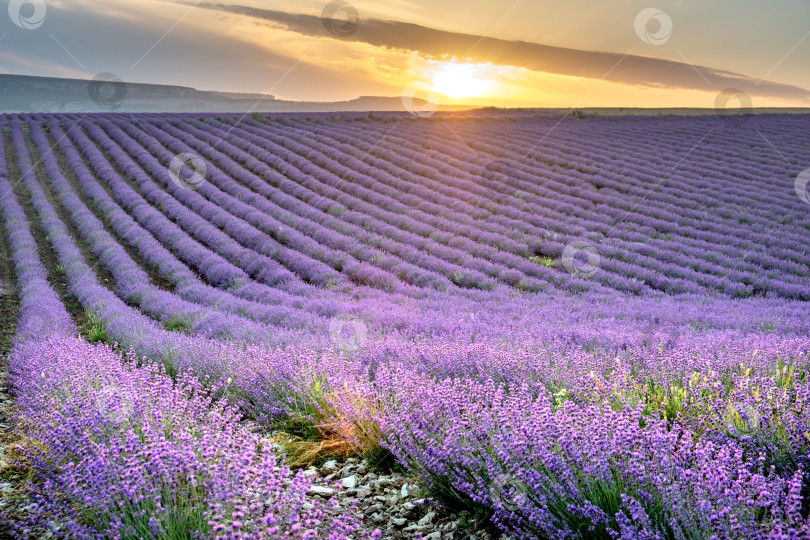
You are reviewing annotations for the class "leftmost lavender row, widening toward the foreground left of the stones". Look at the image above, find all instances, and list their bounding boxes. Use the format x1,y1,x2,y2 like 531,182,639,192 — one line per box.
0,136,366,539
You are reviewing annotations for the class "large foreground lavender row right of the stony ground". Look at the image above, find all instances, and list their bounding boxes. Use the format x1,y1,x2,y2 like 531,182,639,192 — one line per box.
383,360,808,538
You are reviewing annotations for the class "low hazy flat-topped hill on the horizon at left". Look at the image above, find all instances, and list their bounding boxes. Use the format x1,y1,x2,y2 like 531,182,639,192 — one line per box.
0,74,474,113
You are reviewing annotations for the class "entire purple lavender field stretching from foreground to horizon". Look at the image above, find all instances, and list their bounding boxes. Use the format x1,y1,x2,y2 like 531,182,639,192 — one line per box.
0,110,810,540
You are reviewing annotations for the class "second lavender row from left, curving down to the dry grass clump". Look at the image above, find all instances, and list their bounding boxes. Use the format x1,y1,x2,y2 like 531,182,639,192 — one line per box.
11,118,408,422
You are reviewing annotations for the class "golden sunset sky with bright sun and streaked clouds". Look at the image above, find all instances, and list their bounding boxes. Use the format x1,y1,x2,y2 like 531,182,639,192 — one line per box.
0,0,810,107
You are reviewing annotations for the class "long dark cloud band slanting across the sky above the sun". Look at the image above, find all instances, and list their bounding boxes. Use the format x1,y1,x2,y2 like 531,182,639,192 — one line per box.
193,3,810,101
